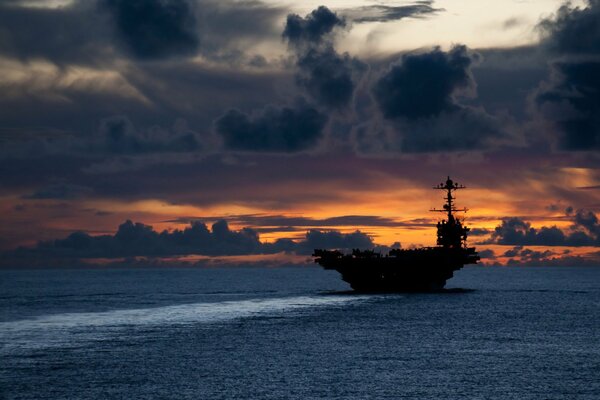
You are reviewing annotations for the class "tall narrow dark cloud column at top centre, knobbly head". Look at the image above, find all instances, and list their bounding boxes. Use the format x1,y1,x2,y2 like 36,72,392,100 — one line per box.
283,6,366,109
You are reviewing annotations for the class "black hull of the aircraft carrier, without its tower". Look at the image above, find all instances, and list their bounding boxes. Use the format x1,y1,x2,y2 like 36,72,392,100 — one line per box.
315,247,479,292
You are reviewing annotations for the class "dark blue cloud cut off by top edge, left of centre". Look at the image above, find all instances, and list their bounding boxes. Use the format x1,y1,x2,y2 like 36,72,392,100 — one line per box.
99,0,199,59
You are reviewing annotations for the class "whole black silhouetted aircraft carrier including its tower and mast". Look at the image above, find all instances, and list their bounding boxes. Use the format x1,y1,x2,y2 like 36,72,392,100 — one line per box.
313,177,479,292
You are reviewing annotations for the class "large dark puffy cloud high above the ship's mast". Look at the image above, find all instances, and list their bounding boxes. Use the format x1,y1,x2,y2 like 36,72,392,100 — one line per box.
370,45,505,153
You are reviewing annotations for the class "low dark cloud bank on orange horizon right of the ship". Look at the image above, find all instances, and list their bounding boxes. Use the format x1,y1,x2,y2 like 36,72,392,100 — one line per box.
485,210,600,246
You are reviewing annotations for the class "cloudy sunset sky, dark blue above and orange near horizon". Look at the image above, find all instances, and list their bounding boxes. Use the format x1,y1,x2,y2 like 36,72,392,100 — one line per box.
0,0,600,266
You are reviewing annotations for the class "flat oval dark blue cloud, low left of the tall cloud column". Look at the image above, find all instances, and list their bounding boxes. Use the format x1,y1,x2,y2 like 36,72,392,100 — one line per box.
215,104,327,153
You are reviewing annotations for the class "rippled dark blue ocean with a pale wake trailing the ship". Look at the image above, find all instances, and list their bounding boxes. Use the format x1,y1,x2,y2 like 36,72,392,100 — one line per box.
0,267,600,399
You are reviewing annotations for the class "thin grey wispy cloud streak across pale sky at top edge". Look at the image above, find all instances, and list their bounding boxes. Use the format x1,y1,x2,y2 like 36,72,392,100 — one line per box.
340,0,444,23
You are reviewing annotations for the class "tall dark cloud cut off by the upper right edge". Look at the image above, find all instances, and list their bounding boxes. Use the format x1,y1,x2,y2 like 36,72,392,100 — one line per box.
533,0,600,151
